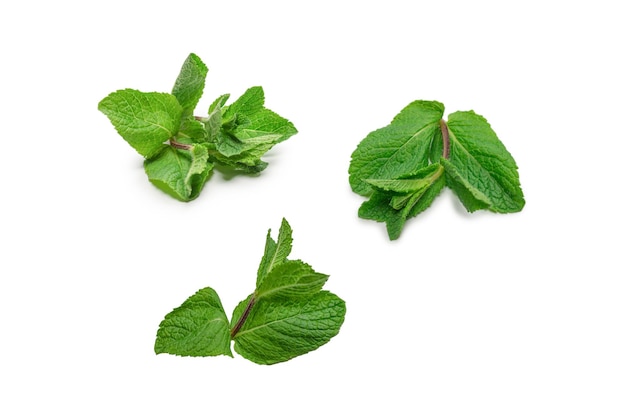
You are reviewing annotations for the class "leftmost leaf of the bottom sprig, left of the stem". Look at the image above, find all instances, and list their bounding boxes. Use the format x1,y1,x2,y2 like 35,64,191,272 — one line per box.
154,287,232,357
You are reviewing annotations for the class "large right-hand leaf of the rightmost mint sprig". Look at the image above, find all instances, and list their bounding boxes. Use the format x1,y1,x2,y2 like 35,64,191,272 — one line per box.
447,111,525,213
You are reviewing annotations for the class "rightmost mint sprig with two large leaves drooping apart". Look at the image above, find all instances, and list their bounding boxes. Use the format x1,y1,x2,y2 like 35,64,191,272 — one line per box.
348,100,525,240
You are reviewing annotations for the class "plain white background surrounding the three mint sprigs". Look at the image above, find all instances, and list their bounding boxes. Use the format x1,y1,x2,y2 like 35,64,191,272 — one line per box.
0,0,626,418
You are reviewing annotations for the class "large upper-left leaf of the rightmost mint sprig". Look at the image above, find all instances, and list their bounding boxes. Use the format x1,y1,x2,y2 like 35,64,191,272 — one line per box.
348,100,444,196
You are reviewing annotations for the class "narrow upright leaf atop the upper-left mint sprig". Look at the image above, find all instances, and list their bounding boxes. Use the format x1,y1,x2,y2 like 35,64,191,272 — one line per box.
172,54,209,114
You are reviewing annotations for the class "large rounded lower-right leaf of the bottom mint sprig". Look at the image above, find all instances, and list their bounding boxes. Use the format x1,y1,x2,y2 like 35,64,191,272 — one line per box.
232,291,346,364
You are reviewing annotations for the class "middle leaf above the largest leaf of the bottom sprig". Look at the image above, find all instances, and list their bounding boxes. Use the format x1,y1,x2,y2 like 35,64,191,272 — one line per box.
255,260,328,300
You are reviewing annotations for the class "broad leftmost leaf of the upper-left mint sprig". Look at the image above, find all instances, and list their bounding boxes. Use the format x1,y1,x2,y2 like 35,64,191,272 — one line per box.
98,89,183,158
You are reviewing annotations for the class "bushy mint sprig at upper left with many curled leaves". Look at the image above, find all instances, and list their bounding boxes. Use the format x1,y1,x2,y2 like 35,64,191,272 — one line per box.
98,54,297,202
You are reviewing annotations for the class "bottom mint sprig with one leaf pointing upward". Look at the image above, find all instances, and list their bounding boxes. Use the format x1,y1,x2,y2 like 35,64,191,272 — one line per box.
154,219,346,364
